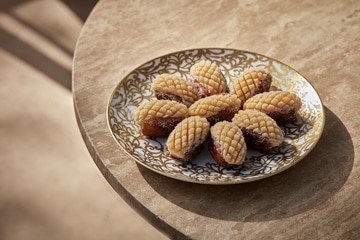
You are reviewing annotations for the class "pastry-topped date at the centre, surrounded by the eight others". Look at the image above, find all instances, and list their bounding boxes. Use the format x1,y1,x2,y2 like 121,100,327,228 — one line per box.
189,93,241,125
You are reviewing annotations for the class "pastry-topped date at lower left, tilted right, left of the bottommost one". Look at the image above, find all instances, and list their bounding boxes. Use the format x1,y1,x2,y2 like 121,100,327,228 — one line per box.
165,116,210,162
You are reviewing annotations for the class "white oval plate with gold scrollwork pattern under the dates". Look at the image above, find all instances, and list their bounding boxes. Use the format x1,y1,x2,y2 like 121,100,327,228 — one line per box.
107,48,325,184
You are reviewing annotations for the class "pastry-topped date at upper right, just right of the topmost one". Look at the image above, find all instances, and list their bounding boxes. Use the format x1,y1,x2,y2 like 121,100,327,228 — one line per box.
230,68,272,103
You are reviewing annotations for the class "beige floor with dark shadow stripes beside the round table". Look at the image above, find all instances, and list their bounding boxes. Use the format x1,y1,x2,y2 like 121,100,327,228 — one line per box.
0,0,166,240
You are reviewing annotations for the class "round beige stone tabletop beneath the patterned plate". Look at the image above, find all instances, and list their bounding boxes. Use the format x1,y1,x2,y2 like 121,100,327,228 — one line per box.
73,0,360,239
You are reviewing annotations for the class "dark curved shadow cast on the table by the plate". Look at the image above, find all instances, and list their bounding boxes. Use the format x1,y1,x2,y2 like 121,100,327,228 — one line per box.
138,108,354,222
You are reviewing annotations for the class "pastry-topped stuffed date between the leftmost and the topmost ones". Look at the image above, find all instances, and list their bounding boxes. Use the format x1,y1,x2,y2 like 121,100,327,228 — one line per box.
151,73,199,107
